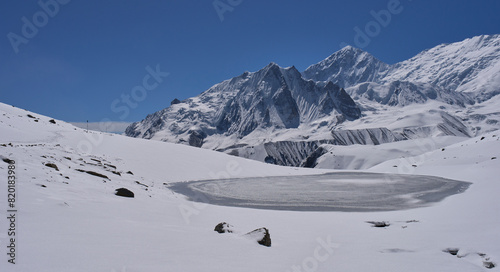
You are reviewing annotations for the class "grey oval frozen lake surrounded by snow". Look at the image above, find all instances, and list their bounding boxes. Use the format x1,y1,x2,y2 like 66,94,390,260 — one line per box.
169,172,470,212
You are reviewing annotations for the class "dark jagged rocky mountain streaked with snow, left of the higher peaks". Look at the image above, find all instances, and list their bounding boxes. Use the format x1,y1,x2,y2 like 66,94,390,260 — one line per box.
126,63,361,148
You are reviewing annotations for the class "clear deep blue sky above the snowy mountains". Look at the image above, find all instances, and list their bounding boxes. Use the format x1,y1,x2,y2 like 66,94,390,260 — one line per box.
0,0,500,122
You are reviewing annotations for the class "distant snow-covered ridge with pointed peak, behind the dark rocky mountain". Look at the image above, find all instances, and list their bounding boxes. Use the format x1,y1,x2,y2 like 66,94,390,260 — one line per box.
303,35,500,102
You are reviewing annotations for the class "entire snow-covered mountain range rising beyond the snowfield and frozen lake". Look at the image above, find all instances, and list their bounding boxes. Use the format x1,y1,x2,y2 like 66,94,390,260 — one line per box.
126,35,500,166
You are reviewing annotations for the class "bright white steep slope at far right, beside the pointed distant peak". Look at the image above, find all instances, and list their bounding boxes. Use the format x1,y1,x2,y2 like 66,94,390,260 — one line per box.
380,35,500,101
